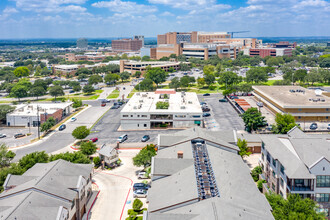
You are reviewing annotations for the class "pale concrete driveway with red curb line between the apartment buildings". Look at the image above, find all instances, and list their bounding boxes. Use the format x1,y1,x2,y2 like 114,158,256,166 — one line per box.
90,150,146,220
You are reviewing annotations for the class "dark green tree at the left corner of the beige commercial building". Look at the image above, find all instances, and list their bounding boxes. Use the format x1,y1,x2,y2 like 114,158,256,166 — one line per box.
242,108,265,132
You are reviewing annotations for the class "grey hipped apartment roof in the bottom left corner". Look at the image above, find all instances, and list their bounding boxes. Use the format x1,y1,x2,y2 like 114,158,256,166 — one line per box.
0,160,93,219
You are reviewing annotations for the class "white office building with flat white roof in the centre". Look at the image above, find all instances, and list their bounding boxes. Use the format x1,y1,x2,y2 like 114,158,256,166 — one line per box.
120,89,203,130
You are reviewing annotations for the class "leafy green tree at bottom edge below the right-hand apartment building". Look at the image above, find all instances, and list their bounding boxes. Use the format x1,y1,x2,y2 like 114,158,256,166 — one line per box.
266,193,325,220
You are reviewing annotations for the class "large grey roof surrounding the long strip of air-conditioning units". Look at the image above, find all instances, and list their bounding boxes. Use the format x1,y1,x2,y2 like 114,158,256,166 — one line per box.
147,128,274,220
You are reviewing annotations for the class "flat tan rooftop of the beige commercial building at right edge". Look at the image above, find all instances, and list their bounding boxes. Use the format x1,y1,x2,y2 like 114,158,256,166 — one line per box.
253,86,330,108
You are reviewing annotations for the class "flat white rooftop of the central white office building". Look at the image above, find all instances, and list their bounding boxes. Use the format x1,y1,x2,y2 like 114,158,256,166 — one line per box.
121,90,203,114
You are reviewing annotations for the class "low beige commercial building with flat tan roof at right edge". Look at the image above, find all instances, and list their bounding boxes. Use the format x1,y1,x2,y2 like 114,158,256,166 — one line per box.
253,86,330,122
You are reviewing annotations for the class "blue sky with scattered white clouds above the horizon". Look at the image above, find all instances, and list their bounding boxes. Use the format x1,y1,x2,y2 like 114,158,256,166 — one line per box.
0,0,330,39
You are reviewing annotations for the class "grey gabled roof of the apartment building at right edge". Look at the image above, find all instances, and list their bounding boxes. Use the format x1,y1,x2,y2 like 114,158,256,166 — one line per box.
259,127,330,179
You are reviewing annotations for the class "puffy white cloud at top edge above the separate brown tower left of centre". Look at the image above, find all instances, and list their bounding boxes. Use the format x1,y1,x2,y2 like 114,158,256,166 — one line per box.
92,0,157,15
